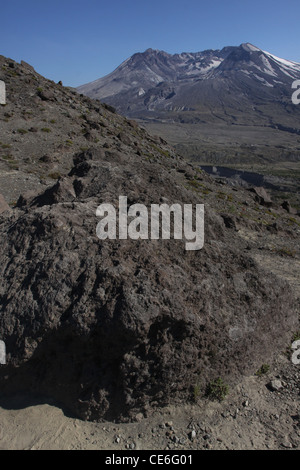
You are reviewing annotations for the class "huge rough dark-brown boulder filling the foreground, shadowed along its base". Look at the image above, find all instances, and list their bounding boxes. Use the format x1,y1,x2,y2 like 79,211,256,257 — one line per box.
0,151,296,420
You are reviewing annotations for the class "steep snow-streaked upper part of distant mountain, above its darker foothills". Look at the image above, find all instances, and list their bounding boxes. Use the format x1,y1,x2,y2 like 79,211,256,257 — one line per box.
78,43,300,109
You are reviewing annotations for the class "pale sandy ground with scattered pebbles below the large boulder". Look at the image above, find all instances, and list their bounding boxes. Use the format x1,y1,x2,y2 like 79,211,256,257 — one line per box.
0,355,300,450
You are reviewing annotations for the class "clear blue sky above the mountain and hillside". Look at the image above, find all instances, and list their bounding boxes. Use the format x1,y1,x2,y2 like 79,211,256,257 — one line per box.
0,0,300,86
